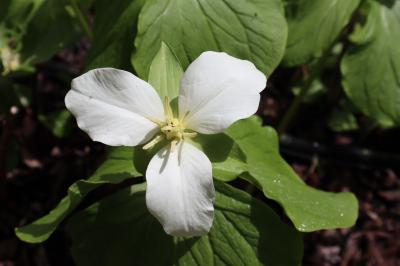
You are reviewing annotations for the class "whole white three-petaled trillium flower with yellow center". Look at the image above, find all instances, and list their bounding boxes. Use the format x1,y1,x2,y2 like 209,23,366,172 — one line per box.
65,52,266,236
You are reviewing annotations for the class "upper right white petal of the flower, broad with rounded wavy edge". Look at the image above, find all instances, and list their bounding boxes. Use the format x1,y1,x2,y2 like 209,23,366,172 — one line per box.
179,52,267,134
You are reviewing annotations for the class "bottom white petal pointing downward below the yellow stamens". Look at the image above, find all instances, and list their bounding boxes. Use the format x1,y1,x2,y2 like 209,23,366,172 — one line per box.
146,141,215,236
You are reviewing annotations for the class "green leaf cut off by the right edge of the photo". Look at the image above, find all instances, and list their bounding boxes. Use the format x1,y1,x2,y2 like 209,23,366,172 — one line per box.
341,0,400,126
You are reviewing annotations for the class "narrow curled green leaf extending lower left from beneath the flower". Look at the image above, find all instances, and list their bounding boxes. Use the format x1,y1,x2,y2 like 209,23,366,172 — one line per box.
15,148,141,243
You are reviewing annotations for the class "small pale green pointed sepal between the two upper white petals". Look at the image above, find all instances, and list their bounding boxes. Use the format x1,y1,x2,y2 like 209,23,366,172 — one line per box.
148,42,183,101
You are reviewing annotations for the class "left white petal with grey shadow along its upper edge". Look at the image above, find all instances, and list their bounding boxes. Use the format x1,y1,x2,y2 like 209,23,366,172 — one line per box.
65,68,164,146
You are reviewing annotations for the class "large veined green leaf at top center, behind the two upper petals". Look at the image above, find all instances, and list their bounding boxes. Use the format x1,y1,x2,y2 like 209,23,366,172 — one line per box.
132,0,287,78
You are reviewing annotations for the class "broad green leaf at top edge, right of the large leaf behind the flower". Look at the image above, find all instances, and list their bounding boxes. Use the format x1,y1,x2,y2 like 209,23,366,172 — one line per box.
283,0,360,66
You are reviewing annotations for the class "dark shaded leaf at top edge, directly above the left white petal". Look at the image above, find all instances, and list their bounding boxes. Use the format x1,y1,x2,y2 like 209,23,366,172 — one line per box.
86,0,145,70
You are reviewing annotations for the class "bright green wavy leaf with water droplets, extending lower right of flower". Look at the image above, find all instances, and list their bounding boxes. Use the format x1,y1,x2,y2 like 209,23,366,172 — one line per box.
226,118,358,232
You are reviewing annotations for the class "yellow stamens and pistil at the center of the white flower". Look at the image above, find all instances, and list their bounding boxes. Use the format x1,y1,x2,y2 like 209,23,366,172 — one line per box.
143,97,197,150
